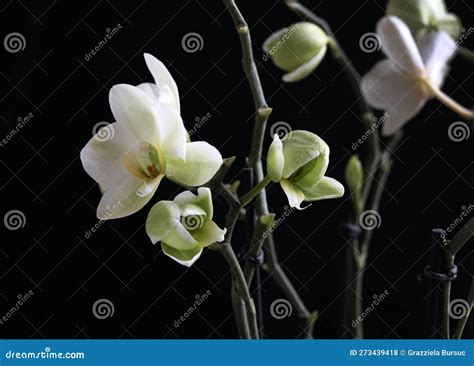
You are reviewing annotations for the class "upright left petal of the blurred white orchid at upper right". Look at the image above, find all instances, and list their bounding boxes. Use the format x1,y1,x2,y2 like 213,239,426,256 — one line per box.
377,16,425,76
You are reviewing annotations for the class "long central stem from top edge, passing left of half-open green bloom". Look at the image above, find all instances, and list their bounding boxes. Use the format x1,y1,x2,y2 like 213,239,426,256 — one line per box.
224,0,314,338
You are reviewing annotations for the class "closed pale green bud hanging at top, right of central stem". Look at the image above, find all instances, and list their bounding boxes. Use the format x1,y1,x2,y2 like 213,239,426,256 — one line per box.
263,22,329,82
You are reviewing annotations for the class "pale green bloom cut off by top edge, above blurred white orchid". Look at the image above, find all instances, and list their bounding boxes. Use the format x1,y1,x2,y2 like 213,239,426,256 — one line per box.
387,0,462,39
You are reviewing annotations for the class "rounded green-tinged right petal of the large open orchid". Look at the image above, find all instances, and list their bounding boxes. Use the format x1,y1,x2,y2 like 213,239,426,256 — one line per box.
166,141,223,187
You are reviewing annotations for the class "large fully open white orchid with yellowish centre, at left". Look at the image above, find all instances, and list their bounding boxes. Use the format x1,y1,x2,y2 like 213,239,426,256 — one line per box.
81,55,223,220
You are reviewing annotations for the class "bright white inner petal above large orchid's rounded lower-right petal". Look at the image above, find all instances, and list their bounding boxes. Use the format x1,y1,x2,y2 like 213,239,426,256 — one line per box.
155,102,187,159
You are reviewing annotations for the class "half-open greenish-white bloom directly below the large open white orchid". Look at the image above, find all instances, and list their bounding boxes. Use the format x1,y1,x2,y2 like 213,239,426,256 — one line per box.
146,187,226,267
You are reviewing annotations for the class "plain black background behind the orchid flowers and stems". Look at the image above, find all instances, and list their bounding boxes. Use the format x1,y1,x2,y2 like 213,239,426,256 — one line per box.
0,0,474,338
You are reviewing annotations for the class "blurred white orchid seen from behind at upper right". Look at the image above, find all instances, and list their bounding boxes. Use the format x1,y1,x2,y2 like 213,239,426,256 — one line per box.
361,16,458,135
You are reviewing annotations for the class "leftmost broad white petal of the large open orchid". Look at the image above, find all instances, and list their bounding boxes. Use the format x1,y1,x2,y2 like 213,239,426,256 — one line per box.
81,122,139,189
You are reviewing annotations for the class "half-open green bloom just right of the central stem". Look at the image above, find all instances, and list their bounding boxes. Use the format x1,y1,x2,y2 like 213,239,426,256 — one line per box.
267,130,344,209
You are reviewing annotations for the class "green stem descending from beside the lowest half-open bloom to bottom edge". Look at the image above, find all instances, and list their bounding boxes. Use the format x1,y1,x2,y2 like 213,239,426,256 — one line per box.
217,243,258,339
